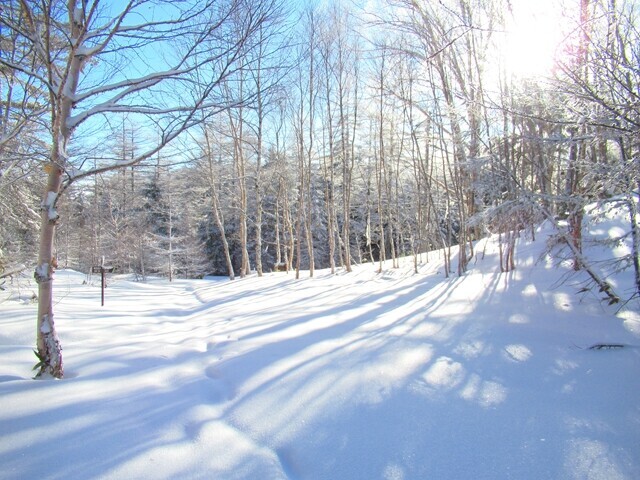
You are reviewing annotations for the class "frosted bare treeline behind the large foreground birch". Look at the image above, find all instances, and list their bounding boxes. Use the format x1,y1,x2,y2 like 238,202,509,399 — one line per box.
0,0,640,285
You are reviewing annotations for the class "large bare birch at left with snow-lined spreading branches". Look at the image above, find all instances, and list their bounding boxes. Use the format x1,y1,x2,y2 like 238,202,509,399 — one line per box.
0,0,278,378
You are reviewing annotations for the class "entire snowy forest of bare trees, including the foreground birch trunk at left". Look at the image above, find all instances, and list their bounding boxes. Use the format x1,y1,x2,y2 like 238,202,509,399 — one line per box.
0,0,640,376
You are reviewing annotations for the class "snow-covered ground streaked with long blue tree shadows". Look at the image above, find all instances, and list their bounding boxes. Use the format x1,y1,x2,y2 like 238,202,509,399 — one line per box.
0,222,640,480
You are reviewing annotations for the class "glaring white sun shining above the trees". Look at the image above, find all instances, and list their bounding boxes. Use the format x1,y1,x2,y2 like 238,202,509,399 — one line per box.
503,0,564,78
